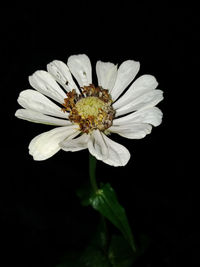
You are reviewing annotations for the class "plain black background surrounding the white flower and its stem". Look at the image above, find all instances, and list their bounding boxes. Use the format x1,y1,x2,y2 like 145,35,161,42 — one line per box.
0,1,200,267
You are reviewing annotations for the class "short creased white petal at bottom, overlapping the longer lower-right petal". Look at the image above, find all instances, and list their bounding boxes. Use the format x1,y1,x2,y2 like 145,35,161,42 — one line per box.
88,130,108,160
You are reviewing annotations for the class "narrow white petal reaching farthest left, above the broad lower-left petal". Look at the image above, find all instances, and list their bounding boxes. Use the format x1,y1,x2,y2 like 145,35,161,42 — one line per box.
15,109,72,126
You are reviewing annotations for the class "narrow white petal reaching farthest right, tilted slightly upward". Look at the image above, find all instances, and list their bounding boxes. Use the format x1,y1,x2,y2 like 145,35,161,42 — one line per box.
115,90,163,117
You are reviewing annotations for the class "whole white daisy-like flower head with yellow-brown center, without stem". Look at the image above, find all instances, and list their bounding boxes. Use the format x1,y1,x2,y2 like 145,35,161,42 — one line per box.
15,54,163,166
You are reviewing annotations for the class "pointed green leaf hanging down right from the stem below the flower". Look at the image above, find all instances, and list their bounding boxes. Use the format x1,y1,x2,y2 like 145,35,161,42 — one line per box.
90,184,136,251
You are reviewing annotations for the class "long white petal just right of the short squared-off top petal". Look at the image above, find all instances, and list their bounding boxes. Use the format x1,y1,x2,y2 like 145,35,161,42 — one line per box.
111,60,140,101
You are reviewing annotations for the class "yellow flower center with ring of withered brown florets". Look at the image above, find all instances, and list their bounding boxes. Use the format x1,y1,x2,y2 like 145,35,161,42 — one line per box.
62,84,115,133
